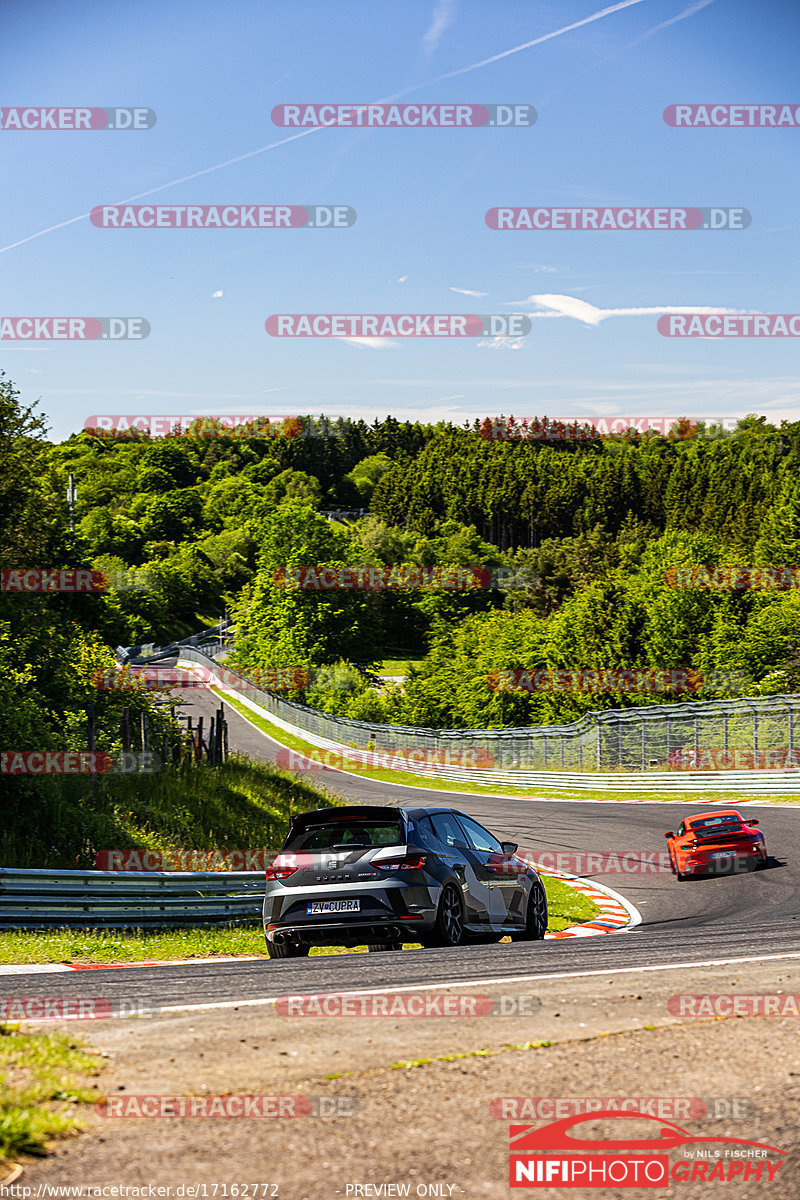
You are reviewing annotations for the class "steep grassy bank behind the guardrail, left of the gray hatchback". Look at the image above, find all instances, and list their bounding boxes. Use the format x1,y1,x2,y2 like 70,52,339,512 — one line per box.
0,757,337,870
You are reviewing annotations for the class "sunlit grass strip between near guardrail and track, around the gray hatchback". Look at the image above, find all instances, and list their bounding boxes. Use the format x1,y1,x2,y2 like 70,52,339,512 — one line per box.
0,876,599,964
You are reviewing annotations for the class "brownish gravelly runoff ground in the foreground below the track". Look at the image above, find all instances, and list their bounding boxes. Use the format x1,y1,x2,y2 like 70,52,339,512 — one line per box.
14,959,800,1200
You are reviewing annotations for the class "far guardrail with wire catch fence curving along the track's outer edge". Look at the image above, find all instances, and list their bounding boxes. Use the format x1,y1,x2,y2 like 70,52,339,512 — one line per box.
180,647,800,793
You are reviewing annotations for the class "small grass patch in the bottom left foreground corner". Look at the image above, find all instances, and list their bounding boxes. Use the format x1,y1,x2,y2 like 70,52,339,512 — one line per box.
0,1025,101,1169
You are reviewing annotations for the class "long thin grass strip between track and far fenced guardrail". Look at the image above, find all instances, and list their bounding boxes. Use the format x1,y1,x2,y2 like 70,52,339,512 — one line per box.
213,689,800,806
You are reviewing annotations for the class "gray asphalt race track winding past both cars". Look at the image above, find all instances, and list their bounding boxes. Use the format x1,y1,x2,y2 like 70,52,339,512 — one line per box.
16,690,800,1007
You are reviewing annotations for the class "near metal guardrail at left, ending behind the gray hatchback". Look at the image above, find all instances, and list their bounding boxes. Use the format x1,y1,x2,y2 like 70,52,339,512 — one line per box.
0,868,264,930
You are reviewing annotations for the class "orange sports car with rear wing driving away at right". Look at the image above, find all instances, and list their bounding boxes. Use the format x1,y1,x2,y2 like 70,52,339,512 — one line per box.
664,809,766,880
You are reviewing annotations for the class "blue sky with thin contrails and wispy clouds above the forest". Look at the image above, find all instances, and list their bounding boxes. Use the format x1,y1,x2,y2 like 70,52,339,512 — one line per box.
0,0,800,438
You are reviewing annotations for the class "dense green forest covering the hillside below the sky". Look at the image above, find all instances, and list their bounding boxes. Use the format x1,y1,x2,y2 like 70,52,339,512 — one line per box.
0,377,800,772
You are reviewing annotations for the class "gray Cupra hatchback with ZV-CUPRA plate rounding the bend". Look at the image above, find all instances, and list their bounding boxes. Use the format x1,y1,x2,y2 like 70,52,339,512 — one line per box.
264,804,547,959
